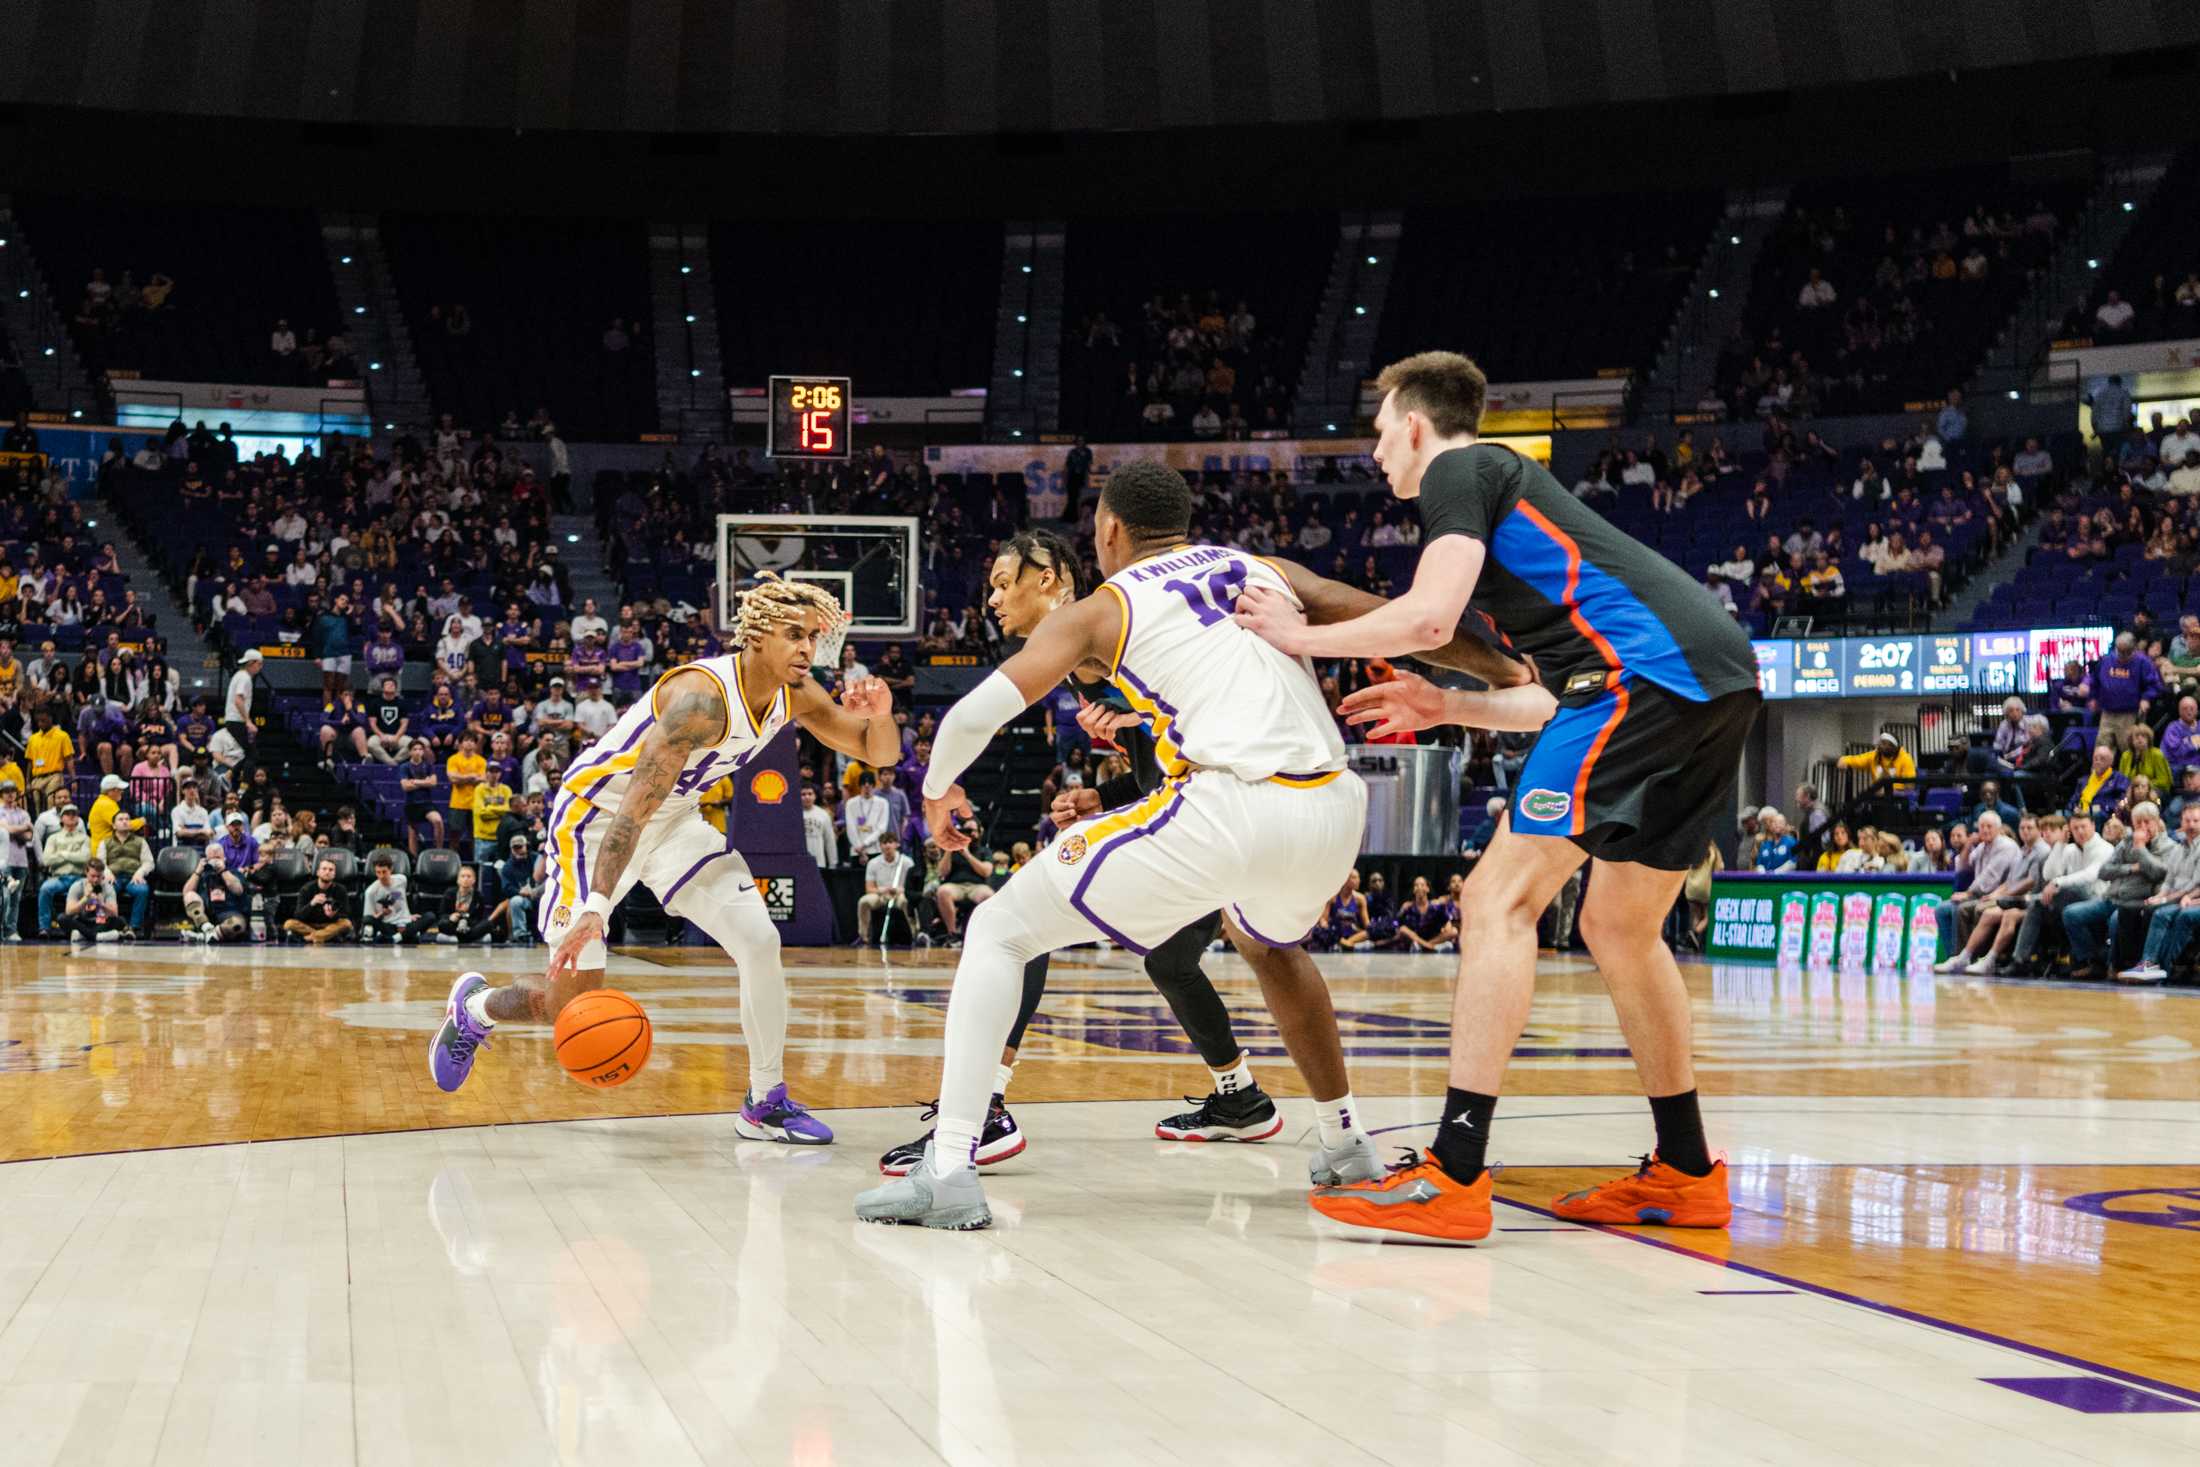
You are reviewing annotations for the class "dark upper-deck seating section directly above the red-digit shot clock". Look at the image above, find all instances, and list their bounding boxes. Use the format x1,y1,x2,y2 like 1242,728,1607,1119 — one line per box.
711,220,1001,398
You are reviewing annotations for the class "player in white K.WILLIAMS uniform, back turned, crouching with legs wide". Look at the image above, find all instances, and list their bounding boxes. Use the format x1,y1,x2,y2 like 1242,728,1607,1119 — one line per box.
856,462,1540,1229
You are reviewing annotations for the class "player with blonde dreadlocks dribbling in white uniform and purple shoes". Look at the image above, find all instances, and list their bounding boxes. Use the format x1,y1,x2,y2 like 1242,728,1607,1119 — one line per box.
429,572,902,1146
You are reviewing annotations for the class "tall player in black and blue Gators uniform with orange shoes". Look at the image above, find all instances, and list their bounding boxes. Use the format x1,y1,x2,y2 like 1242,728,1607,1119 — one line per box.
1236,352,1760,1240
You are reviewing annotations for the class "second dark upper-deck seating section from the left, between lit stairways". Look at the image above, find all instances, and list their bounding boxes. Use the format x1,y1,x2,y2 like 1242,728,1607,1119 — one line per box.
383,213,658,440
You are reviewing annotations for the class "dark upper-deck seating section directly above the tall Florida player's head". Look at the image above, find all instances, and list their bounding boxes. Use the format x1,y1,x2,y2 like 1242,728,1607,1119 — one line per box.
1375,194,1718,383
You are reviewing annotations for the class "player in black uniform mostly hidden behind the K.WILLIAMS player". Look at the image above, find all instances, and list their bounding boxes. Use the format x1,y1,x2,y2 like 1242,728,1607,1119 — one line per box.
878,530,1525,1179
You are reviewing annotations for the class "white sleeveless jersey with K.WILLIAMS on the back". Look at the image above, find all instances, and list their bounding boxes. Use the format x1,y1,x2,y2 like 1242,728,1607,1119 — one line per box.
1102,545,1344,781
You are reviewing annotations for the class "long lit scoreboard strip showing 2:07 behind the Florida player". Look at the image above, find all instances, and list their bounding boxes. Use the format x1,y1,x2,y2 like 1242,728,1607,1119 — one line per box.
1751,627,2116,702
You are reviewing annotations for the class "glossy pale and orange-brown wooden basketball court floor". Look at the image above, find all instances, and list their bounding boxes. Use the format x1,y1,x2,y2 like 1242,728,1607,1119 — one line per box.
0,946,2200,1463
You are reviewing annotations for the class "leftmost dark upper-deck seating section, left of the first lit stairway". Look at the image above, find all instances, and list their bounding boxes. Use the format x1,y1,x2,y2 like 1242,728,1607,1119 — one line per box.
15,196,343,385
